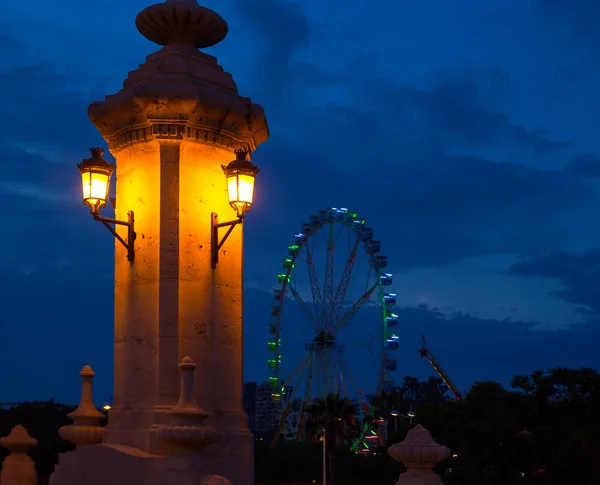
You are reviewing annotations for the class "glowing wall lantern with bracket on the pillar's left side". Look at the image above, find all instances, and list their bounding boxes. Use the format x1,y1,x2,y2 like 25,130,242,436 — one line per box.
77,148,135,261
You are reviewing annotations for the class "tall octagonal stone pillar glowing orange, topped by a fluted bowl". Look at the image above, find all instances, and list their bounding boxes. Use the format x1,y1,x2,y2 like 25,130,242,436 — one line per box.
55,0,268,485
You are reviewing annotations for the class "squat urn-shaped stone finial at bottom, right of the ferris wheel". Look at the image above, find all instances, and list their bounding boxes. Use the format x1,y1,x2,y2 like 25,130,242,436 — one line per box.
388,424,450,485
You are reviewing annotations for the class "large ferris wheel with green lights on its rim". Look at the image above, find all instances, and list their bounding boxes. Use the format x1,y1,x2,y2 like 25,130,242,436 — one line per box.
268,207,399,443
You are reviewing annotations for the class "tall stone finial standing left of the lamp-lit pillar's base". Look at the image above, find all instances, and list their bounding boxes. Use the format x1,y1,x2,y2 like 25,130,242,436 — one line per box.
58,365,104,446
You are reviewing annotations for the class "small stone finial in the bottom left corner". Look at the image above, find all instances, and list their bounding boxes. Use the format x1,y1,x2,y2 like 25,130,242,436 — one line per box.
0,424,38,485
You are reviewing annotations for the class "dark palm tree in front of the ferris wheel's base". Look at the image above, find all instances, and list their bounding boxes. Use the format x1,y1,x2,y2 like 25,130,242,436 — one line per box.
305,392,356,485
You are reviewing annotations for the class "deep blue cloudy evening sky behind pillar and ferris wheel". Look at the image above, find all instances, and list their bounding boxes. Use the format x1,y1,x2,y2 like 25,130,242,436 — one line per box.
0,0,600,404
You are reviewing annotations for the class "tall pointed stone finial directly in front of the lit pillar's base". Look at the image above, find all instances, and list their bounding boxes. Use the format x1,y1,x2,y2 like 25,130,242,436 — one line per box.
157,357,217,449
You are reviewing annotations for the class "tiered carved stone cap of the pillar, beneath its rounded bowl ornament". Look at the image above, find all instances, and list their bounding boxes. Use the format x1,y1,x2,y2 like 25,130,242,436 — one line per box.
88,44,269,150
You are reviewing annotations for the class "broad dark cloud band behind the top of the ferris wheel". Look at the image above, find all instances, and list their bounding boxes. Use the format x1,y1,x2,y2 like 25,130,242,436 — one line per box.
246,141,595,288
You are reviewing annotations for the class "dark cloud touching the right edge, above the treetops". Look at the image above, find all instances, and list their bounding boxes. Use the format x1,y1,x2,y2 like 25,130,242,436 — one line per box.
509,249,600,312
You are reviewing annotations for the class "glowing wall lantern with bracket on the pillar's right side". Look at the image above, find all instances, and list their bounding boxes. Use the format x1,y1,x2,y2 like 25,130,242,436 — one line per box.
211,149,260,269
